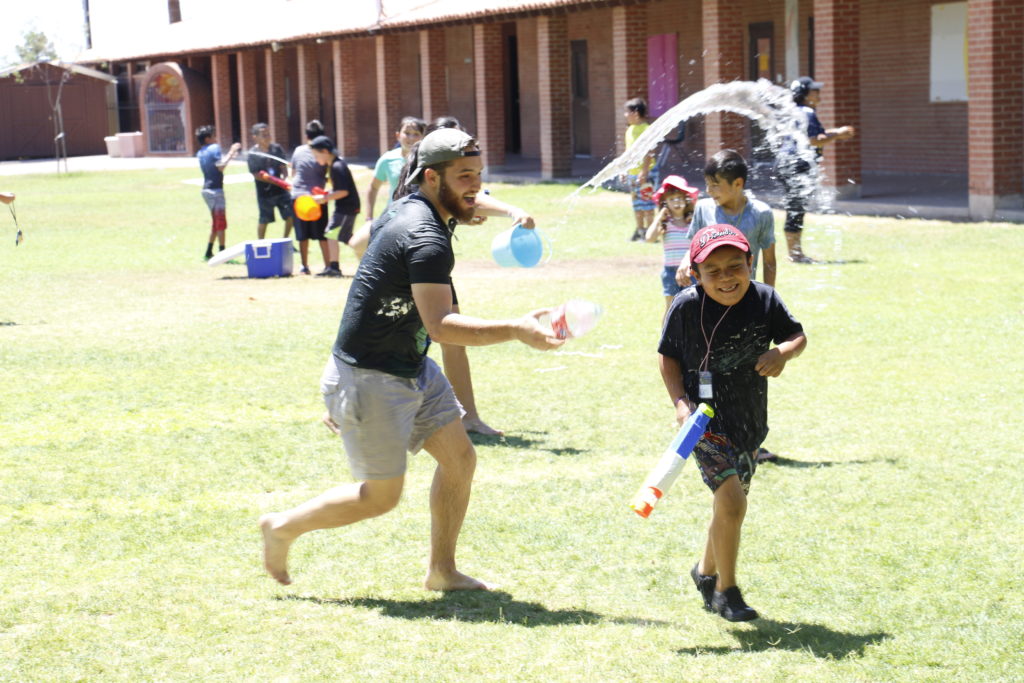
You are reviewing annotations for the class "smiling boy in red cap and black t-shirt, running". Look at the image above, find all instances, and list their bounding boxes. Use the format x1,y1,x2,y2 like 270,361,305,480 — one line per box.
657,224,807,622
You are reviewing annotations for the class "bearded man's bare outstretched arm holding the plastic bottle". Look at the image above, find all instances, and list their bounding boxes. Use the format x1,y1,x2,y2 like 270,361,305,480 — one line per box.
413,283,564,351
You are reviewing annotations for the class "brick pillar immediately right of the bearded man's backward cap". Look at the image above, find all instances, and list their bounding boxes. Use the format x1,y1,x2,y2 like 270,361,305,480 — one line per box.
473,24,505,168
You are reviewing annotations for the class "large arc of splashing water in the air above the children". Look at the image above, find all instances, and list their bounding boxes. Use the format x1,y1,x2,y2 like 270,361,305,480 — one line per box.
581,79,821,208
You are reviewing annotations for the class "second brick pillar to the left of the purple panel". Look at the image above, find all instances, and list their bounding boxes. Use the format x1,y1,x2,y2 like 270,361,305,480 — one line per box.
537,15,572,178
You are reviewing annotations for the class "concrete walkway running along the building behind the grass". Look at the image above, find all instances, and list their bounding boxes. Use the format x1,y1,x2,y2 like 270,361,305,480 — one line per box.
0,155,1024,223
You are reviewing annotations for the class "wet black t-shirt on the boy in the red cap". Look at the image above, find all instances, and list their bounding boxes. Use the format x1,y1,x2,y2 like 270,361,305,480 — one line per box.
657,281,804,451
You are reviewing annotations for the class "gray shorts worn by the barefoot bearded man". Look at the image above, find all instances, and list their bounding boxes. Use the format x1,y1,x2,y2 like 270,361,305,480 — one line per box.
321,354,464,481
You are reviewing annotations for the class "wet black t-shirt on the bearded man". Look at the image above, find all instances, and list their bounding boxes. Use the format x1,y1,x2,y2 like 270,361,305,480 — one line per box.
334,193,455,378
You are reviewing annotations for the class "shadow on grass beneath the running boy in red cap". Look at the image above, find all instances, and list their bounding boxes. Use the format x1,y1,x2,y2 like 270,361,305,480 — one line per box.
676,618,891,659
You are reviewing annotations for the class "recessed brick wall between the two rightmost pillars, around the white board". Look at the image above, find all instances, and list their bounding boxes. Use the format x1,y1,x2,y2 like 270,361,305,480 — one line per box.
860,0,968,173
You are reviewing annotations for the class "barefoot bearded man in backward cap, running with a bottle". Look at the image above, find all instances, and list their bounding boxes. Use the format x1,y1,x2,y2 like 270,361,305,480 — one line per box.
260,128,562,591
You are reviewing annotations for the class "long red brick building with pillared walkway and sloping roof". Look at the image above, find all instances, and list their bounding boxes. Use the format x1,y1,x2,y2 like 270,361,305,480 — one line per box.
81,0,1024,218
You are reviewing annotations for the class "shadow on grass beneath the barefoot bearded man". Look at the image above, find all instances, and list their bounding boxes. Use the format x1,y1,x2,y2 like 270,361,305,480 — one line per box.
275,591,670,628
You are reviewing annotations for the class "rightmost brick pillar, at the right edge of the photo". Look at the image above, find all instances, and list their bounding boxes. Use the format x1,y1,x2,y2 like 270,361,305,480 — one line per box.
968,0,1024,206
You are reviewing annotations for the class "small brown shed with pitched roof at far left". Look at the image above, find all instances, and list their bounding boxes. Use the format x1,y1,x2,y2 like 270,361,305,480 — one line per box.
0,61,118,160
